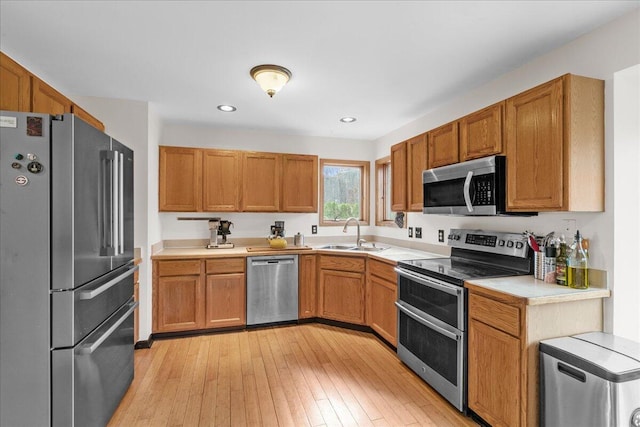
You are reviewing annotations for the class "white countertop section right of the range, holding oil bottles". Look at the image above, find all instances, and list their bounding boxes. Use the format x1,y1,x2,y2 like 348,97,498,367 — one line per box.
465,276,611,305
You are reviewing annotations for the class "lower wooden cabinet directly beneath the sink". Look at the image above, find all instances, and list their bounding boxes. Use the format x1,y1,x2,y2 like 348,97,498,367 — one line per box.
318,255,366,325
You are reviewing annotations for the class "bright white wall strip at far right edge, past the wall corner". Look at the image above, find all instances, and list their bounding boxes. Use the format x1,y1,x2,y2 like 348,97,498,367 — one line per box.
613,65,640,342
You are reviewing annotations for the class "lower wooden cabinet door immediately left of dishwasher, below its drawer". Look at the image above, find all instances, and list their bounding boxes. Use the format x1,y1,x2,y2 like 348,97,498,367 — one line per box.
205,273,247,328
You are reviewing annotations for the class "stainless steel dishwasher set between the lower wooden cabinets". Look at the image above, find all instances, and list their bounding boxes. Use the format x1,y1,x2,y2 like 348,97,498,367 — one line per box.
247,255,298,326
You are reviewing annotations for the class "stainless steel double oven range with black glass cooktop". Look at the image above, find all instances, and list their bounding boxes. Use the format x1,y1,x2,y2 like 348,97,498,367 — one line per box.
396,229,533,412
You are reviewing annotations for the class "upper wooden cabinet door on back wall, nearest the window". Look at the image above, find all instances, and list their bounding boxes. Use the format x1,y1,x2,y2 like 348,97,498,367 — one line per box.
281,154,318,212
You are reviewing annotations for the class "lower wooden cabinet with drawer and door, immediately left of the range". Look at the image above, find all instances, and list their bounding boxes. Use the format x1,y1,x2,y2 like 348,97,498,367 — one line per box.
367,259,398,346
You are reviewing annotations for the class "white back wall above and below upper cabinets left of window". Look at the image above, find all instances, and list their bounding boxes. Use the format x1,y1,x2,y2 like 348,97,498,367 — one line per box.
160,124,374,241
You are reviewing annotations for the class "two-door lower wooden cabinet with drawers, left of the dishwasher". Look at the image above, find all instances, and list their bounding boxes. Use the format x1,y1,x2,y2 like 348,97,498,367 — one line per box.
153,257,246,332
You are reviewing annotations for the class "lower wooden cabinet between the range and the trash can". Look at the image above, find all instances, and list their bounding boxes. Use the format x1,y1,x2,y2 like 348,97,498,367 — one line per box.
465,282,603,427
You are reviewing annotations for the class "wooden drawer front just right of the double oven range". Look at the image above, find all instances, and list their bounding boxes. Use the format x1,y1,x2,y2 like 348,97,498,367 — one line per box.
469,293,520,337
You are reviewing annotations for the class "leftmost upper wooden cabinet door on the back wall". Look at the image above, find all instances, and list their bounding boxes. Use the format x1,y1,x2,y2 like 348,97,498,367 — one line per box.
158,147,202,212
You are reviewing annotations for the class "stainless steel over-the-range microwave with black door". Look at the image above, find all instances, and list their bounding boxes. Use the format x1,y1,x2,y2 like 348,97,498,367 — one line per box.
422,156,536,216
